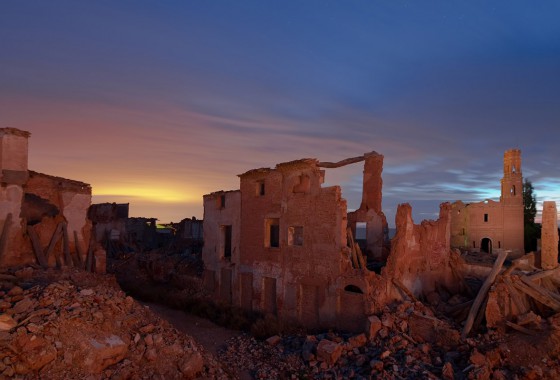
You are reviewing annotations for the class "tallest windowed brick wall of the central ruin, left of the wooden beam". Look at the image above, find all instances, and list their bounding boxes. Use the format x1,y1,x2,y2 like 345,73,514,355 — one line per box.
239,160,346,326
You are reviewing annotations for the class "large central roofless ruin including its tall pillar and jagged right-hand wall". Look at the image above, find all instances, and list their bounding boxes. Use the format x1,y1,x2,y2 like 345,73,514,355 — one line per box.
202,152,458,331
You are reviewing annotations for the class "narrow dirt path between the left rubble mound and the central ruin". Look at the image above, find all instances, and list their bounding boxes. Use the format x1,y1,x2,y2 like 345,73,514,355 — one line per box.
143,302,253,380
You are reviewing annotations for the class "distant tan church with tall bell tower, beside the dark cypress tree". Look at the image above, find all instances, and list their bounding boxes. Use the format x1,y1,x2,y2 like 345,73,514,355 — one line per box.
451,149,524,257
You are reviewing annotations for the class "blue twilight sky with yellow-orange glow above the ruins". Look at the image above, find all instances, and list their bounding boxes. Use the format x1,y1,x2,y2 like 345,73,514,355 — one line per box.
0,0,560,225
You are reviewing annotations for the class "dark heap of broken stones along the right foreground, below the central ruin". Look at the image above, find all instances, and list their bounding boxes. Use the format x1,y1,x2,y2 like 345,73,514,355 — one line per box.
220,302,560,379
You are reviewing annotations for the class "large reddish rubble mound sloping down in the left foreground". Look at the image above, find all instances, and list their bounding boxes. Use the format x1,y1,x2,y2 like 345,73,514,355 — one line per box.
0,267,228,379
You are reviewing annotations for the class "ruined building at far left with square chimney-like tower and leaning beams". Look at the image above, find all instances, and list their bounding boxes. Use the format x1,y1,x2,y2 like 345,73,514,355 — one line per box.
0,128,105,272
